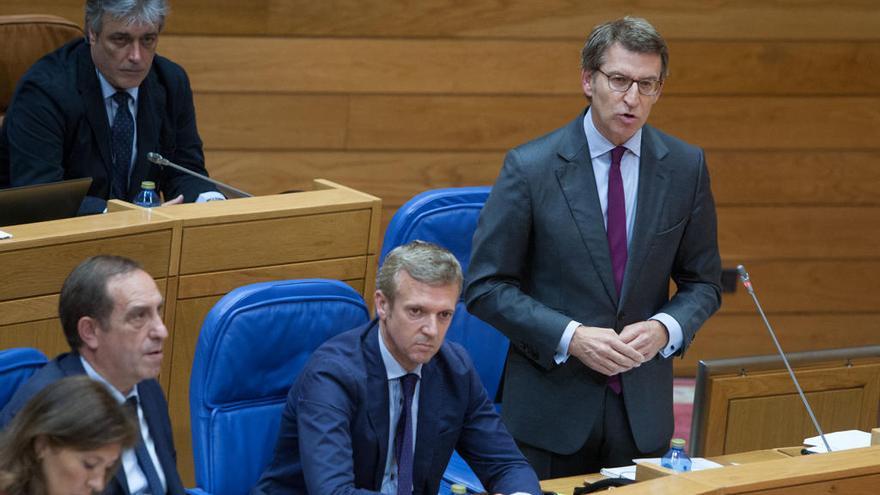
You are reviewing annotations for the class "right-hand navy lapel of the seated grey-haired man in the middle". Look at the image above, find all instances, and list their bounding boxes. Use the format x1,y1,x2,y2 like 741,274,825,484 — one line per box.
413,359,447,491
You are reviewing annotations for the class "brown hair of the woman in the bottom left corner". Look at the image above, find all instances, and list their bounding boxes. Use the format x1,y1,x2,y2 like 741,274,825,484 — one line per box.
0,375,139,495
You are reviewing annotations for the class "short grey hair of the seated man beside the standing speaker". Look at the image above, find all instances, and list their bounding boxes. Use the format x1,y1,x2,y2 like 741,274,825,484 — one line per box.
376,240,462,306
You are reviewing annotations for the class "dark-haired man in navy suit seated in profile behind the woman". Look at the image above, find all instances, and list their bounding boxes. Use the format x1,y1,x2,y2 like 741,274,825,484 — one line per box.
0,256,185,495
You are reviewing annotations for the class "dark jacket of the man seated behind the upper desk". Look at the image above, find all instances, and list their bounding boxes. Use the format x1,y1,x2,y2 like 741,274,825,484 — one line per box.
0,39,215,201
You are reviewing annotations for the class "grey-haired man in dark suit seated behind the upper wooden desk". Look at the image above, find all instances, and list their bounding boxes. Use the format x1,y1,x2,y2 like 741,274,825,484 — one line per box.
0,0,223,209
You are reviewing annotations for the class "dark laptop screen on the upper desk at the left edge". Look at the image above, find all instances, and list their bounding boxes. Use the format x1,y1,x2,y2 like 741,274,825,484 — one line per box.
0,177,92,227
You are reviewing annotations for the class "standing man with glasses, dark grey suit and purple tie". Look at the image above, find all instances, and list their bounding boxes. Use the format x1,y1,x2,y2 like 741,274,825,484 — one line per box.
465,17,721,479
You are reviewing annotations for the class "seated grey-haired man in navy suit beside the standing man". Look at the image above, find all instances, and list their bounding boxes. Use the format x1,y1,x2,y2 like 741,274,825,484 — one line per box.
252,241,541,495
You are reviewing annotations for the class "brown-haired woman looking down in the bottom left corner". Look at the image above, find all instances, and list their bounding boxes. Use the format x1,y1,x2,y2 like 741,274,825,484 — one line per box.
0,376,138,495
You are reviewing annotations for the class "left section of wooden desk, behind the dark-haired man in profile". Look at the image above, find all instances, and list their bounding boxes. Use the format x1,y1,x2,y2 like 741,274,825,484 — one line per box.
0,209,180,366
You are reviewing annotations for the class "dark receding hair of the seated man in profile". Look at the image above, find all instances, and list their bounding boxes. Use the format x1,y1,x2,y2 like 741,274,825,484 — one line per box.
58,255,143,351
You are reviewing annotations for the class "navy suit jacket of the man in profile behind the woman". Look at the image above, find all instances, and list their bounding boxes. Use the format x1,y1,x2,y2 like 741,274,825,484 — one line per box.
0,353,185,495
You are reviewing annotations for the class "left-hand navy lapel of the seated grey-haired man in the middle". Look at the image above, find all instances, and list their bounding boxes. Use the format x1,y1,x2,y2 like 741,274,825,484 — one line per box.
363,320,390,490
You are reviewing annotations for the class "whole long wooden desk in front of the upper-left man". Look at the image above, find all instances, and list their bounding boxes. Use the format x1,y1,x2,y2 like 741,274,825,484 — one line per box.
0,179,381,486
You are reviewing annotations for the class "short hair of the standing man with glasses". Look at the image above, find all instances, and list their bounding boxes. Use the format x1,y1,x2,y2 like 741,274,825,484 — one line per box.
581,16,669,80
